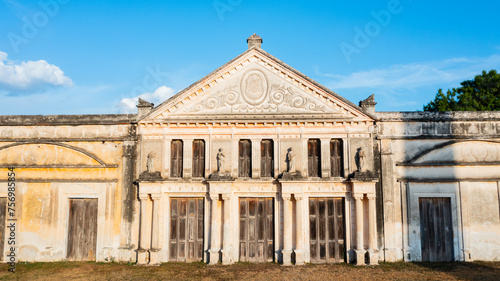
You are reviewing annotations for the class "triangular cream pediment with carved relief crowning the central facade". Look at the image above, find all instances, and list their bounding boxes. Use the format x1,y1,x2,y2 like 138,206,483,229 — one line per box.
142,48,373,121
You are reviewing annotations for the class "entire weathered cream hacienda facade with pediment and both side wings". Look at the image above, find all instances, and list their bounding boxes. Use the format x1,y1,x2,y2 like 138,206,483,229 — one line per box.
0,34,500,265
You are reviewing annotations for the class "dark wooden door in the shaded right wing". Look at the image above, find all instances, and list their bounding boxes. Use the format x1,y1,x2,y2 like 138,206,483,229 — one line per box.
419,197,453,262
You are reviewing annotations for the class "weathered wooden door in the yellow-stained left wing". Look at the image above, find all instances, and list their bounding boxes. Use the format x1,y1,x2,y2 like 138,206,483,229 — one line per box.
67,199,98,261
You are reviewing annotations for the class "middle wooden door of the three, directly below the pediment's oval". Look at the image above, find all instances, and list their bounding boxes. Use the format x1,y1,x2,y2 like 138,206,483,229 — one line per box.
239,198,274,262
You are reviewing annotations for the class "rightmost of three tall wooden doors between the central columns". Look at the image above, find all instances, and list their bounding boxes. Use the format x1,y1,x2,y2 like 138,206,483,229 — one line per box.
309,198,345,263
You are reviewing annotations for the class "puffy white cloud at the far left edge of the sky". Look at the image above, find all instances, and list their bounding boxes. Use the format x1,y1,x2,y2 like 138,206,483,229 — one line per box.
0,51,73,92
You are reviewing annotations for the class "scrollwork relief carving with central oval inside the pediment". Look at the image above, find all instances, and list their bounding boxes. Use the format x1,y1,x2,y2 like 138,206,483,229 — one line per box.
182,69,331,114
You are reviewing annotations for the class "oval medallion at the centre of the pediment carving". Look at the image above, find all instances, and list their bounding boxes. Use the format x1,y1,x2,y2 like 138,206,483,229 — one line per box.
241,70,267,105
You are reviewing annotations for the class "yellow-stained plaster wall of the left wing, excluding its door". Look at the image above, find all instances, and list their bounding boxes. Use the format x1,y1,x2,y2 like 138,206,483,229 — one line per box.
0,115,135,261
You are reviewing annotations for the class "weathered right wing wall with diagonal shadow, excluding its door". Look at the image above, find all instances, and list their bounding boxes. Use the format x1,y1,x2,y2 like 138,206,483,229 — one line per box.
377,112,500,261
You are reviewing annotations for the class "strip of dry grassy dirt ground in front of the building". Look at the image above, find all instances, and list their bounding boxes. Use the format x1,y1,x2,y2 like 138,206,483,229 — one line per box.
0,262,500,281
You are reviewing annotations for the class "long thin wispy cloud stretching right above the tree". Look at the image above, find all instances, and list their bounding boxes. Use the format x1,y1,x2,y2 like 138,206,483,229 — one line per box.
317,54,500,90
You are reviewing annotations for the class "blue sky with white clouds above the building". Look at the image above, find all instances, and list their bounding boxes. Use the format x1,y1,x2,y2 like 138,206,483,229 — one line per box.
0,0,500,115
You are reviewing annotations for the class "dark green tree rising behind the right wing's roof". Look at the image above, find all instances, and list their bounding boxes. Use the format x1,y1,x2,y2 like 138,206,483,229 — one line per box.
424,70,500,111
